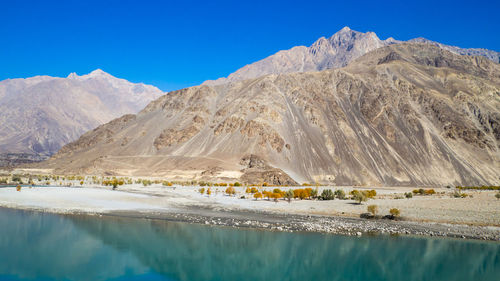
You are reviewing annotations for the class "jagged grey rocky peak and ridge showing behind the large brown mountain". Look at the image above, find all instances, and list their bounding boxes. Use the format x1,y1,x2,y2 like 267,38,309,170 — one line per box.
203,26,500,86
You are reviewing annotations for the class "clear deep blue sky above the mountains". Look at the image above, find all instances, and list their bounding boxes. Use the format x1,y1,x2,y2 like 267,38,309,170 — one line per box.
0,0,500,90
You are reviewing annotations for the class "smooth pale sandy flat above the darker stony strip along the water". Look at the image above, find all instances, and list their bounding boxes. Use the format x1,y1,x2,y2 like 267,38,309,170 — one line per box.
0,185,500,226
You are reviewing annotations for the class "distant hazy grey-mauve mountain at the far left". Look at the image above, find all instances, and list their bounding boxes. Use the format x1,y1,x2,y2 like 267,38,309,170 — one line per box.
0,69,163,165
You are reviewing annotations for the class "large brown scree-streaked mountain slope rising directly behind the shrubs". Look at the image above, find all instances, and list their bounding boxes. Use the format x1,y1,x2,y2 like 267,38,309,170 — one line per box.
40,43,500,186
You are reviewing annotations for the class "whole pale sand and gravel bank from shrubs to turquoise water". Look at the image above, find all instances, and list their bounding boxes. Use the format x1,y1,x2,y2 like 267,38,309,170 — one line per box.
0,185,500,241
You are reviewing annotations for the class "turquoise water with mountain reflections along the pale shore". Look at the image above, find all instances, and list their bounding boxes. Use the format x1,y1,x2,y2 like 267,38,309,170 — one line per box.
0,208,500,280
